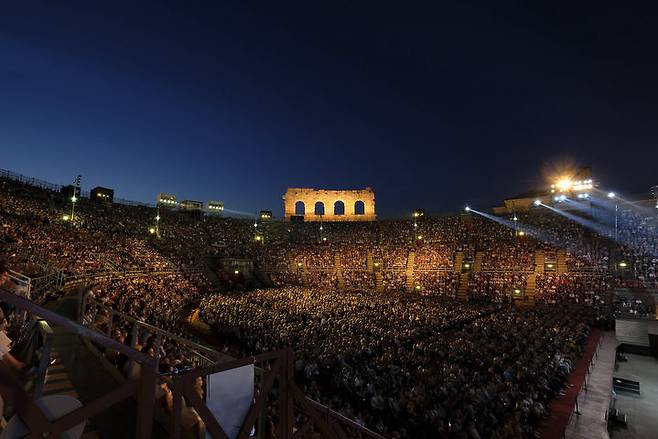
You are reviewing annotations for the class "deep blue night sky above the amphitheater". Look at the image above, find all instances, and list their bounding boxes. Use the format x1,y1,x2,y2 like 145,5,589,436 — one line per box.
0,0,658,216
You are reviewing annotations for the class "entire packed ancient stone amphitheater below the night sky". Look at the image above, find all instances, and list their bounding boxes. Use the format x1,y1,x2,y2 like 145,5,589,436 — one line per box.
0,171,658,439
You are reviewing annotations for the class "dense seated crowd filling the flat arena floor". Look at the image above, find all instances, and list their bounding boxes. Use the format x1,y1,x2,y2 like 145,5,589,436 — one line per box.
201,287,589,438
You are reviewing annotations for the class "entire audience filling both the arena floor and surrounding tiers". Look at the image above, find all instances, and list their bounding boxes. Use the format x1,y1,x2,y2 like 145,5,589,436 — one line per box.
0,175,658,439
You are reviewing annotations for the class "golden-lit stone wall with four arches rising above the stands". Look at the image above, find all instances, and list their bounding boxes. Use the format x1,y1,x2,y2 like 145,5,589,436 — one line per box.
283,187,377,221
